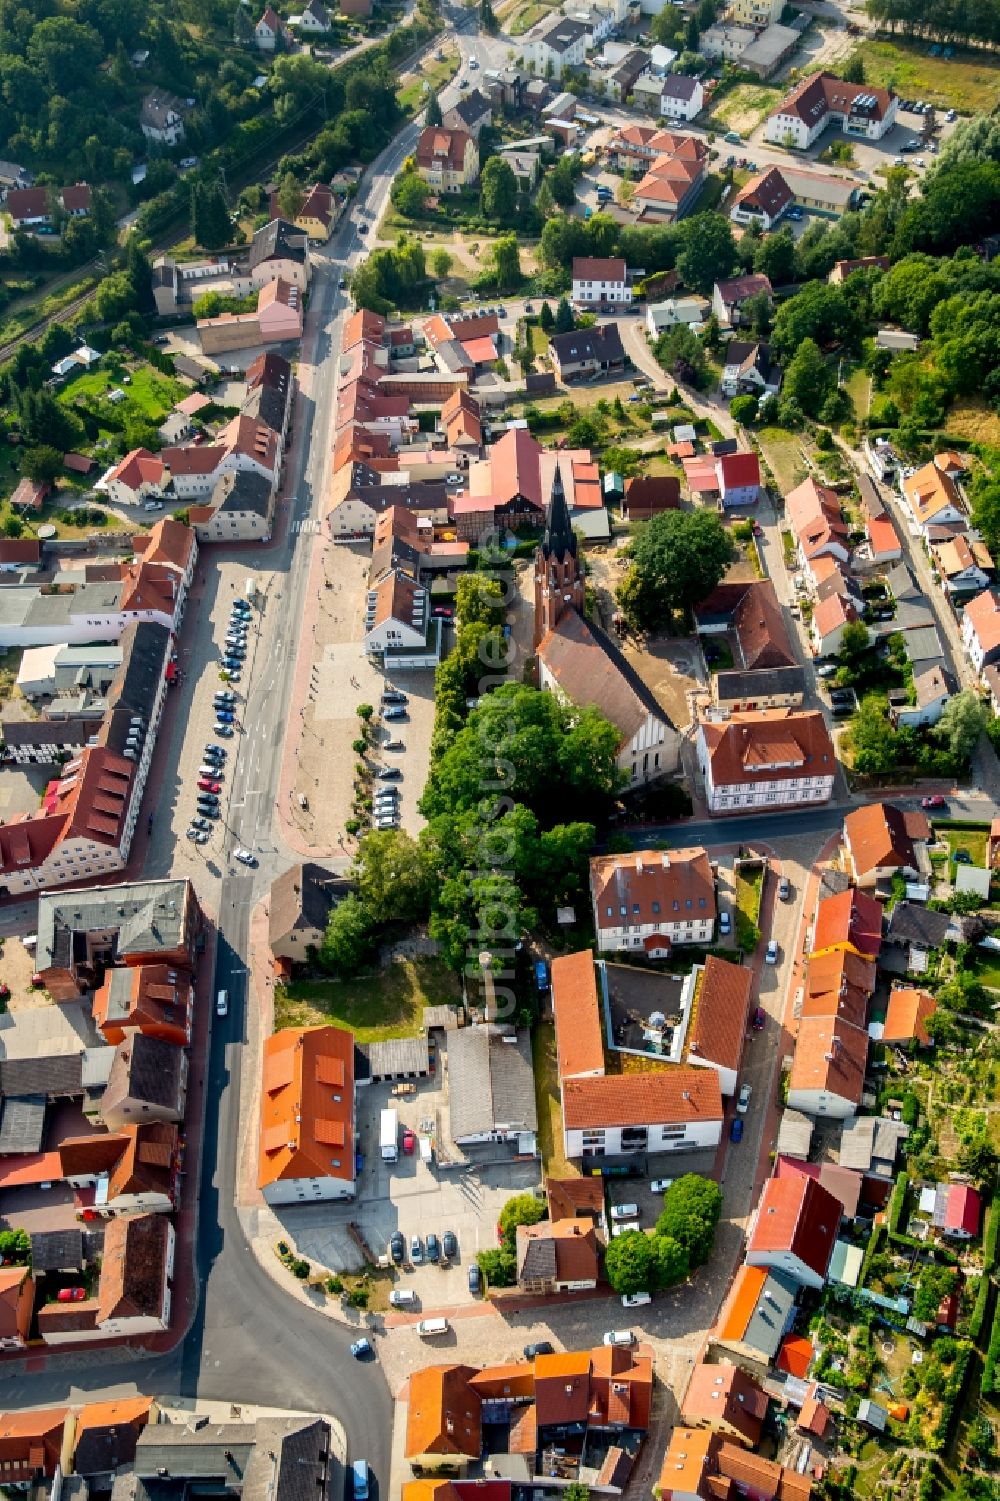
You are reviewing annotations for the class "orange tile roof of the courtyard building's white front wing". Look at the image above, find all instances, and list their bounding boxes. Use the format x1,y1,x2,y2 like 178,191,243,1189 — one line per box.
563,1067,722,1130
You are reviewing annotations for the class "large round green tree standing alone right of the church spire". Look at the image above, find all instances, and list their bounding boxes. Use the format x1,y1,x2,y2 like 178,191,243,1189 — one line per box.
619,510,734,629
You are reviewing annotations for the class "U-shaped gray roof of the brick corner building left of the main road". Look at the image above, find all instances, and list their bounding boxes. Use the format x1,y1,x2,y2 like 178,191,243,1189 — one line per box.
36,876,191,970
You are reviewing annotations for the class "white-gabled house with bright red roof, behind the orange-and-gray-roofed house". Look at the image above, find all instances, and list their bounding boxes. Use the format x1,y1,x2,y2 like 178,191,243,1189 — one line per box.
746,1177,841,1288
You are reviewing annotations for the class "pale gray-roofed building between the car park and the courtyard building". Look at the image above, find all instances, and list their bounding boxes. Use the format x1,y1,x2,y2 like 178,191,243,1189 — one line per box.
447,1024,538,1142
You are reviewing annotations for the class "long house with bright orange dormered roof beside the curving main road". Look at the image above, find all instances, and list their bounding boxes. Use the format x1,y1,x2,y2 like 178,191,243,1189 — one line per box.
257,1027,354,1205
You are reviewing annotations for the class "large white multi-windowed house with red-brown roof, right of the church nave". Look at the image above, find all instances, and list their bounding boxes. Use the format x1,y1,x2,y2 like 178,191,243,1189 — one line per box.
695,708,836,814
